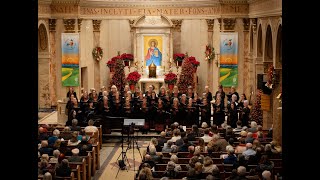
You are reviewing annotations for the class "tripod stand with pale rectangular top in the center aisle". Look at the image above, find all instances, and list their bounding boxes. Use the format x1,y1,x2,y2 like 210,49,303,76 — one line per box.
123,119,145,171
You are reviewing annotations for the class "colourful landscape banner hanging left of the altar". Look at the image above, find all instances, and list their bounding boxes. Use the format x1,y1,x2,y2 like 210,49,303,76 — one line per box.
61,33,79,86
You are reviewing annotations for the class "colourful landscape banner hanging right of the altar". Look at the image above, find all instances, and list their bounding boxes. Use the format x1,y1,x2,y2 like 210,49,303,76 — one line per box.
219,33,238,87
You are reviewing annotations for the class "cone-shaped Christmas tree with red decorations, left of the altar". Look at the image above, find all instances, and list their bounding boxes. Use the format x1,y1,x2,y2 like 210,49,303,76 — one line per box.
109,56,126,92
